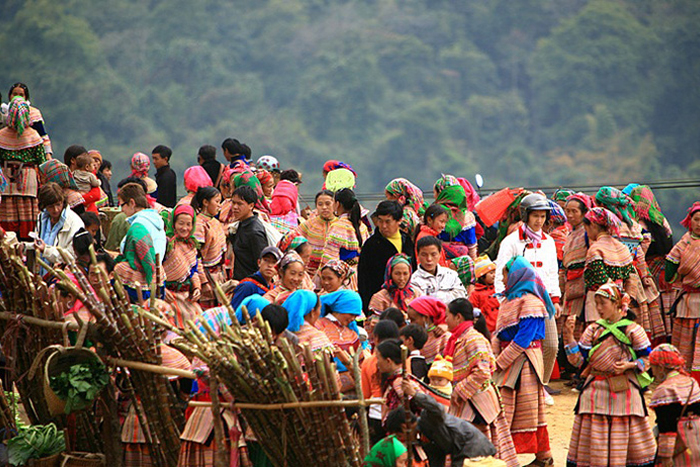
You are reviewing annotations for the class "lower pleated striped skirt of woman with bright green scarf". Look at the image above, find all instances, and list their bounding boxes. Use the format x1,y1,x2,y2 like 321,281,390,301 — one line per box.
566,414,656,467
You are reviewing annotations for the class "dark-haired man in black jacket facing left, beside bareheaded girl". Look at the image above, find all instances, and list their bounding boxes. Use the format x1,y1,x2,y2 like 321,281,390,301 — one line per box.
229,186,267,281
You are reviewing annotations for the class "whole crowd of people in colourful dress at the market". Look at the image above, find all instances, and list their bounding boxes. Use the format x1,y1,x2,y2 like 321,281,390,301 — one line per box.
0,83,700,467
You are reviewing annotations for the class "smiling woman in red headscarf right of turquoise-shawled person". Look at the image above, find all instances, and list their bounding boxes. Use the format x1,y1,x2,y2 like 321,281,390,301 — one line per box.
163,204,202,329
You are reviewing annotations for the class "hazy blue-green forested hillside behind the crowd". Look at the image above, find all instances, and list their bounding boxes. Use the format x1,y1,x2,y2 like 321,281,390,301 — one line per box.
0,0,700,223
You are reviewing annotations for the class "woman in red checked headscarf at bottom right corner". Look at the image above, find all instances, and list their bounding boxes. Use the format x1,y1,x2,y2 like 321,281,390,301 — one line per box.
649,344,700,467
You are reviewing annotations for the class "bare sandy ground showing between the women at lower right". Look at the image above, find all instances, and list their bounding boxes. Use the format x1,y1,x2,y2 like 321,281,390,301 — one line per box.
518,381,656,467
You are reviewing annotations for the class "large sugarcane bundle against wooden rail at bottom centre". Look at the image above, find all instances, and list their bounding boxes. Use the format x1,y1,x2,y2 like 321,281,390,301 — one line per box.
158,290,362,467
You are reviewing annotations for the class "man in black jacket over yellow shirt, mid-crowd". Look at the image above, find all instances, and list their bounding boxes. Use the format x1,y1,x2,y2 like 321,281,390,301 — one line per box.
357,201,413,316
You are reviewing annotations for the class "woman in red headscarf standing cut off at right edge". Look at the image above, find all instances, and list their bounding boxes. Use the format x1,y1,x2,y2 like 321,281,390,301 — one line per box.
666,201,700,379
